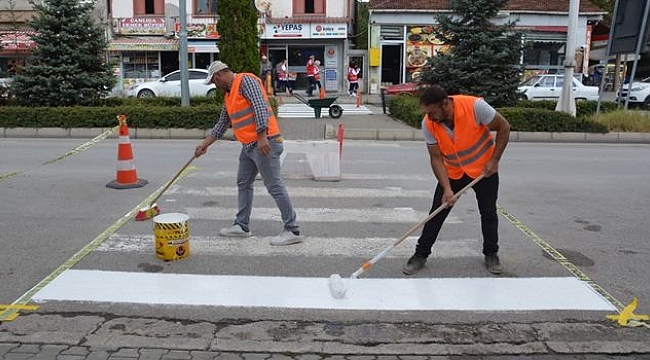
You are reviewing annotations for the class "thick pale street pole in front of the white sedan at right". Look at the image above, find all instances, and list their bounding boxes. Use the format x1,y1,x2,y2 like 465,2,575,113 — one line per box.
555,0,580,116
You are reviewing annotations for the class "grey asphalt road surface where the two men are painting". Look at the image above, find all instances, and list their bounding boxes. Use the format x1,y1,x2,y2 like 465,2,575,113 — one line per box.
0,139,650,354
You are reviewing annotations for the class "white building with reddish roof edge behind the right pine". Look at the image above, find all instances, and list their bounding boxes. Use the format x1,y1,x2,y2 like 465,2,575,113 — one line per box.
368,0,605,93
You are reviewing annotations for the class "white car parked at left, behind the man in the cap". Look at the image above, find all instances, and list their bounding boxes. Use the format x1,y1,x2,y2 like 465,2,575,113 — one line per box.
127,69,217,98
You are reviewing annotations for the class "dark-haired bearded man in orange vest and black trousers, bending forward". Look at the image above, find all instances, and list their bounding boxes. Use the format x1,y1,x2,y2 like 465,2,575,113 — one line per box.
403,85,510,275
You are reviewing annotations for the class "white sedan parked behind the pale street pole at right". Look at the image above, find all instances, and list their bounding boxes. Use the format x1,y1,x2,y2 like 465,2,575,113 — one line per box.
519,75,598,100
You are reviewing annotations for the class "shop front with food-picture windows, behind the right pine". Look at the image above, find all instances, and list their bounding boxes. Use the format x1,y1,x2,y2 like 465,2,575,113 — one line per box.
368,4,601,94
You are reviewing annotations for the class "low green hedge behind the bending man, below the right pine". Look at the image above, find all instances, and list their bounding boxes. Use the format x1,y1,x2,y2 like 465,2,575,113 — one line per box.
388,94,616,133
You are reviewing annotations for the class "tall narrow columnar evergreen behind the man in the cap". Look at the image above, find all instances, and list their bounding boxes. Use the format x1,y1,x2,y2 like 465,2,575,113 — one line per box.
217,0,260,74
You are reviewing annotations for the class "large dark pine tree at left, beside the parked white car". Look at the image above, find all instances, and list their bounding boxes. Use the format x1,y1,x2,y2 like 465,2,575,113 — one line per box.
12,0,115,106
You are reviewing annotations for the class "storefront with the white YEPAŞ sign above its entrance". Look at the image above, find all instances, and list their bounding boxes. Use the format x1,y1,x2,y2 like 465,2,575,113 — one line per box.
260,23,348,92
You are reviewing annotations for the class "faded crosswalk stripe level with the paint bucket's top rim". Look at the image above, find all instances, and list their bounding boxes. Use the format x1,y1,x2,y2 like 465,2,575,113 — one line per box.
186,207,462,224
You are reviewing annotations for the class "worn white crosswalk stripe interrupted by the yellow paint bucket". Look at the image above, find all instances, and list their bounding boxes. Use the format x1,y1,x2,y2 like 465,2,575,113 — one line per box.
95,235,481,258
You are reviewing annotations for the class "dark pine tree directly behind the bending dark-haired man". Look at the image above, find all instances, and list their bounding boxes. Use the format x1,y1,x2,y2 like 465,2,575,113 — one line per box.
420,0,523,106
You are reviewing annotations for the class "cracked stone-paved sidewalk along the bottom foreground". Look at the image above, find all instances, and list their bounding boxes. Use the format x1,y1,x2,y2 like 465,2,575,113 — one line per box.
0,314,650,360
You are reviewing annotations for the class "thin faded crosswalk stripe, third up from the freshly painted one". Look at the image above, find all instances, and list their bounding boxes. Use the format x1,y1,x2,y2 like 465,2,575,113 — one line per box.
168,186,433,199
